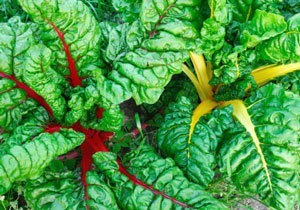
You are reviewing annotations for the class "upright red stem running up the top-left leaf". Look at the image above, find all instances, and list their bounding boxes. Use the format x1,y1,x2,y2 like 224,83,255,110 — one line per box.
46,19,82,87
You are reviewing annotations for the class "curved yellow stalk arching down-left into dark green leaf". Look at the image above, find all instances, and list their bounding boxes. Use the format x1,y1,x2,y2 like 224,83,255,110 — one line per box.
187,99,218,158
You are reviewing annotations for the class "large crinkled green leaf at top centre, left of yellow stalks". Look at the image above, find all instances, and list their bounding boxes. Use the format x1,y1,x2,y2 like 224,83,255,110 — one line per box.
94,0,199,104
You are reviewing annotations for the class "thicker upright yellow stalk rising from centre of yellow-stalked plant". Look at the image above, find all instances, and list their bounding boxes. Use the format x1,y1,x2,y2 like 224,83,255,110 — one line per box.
190,52,213,101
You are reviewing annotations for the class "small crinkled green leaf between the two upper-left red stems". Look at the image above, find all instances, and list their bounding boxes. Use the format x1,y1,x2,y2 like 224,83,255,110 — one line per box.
22,44,66,120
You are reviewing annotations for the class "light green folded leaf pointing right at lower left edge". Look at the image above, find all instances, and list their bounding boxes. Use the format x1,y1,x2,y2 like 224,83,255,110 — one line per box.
0,129,84,195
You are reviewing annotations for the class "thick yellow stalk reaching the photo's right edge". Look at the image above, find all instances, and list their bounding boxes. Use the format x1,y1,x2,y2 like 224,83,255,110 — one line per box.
251,62,300,86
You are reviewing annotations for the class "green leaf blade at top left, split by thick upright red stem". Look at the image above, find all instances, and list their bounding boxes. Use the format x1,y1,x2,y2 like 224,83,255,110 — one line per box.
19,0,101,76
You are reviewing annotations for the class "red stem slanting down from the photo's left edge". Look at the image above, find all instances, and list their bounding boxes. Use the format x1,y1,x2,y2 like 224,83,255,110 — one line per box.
0,72,53,117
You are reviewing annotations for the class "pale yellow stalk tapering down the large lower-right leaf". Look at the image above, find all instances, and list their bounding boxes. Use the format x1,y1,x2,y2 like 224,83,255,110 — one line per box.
224,100,273,191
